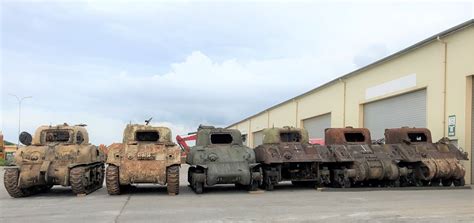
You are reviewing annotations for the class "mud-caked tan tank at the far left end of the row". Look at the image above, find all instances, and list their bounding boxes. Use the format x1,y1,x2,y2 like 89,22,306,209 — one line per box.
4,124,105,197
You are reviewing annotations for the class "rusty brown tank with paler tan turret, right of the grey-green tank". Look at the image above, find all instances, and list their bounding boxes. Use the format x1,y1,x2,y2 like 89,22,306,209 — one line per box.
254,127,331,190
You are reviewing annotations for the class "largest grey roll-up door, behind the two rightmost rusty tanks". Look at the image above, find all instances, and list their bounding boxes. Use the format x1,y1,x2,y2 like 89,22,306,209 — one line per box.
364,90,426,140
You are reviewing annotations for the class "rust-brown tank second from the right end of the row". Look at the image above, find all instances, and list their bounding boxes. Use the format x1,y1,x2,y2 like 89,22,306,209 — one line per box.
325,127,408,187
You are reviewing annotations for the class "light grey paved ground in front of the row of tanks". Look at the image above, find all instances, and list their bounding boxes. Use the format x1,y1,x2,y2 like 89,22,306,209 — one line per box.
0,167,474,223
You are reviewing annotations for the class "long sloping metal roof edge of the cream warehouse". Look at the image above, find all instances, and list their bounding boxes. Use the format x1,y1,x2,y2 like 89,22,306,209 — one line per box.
226,19,474,128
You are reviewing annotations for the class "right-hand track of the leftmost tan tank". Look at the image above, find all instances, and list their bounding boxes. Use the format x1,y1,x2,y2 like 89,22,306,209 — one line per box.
69,163,104,195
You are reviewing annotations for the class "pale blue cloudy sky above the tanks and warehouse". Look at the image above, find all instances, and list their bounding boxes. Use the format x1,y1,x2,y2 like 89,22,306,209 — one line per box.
0,0,474,144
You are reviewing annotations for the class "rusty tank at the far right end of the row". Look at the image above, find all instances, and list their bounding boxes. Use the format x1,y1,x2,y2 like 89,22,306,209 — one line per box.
385,127,468,186
